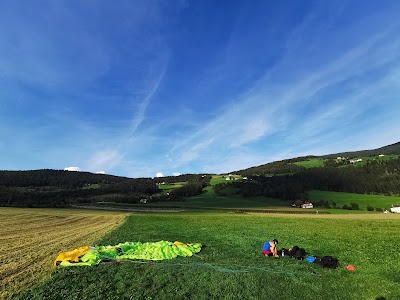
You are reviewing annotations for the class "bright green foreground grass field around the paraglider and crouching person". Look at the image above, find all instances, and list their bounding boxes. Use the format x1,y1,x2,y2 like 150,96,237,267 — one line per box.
15,212,400,300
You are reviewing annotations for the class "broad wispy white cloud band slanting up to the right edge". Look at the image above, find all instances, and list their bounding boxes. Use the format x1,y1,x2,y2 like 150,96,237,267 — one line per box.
167,25,400,173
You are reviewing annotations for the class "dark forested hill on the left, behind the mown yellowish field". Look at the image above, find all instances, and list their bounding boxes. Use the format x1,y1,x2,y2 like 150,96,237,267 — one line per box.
0,170,211,207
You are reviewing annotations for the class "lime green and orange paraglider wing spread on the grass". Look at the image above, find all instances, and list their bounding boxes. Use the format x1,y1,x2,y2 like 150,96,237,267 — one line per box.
54,241,202,266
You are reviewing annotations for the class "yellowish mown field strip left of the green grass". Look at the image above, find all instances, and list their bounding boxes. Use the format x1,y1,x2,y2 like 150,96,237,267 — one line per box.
0,208,126,299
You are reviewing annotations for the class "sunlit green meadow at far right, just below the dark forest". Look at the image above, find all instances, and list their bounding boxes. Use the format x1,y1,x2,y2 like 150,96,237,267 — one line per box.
307,191,400,210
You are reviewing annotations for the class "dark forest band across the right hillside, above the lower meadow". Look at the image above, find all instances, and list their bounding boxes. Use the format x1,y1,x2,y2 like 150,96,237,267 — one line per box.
229,158,400,200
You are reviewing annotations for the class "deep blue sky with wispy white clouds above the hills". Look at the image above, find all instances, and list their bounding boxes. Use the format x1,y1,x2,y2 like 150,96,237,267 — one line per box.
0,0,400,177
